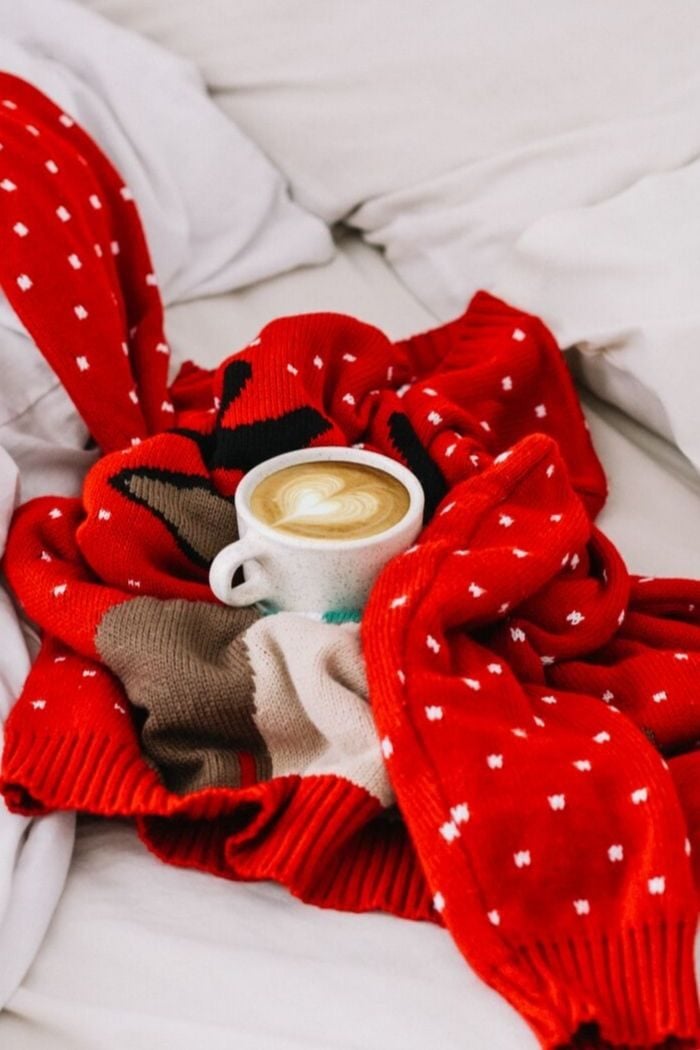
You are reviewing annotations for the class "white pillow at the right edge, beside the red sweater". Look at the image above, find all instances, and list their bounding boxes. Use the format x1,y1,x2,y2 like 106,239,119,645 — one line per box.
495,162,700,472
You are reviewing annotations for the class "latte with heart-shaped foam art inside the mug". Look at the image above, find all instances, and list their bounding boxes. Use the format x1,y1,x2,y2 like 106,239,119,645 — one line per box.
250,460,410,541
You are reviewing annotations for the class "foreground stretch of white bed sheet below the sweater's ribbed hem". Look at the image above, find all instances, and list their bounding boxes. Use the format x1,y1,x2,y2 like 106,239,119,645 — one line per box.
0,820,537,1050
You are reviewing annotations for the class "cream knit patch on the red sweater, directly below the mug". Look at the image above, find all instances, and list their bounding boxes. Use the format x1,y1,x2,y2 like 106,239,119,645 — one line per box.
246,612,394,806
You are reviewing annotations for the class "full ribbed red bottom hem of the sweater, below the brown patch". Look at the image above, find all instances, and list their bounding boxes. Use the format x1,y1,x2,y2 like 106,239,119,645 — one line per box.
0,726,436,920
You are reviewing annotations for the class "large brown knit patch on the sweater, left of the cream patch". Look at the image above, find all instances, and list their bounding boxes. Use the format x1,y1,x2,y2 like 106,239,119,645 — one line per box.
96,596,272,793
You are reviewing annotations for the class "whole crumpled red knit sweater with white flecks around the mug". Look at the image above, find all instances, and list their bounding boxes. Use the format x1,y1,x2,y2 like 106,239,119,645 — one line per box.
0,77,700,1048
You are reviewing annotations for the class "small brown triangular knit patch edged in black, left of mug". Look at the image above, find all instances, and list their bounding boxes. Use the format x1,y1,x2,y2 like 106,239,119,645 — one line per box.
126,471,238,562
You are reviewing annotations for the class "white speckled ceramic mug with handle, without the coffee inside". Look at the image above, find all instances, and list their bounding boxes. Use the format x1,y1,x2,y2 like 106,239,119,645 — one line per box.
209,446,424,613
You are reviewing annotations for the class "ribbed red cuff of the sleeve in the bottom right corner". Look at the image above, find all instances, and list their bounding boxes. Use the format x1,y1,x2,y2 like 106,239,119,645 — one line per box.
487,915,700,1050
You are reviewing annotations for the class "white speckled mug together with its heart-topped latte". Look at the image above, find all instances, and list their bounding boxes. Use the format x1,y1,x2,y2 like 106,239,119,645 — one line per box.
209,446,424,613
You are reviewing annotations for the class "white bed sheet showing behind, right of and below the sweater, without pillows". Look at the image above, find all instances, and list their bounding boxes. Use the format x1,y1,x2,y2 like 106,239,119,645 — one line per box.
0,239,700,1050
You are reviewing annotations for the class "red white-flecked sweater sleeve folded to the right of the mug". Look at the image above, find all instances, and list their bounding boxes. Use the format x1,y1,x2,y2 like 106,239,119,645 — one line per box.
363,436,700,1048
